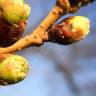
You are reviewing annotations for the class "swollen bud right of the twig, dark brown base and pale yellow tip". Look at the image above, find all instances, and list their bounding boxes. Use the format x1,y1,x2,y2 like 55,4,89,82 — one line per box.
48,16,90,44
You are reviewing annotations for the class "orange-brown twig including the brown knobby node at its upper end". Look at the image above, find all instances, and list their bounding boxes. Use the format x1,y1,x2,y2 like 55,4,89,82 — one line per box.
0,0,95,54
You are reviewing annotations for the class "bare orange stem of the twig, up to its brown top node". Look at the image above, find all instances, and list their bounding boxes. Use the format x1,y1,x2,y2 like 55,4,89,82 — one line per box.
0,0,69,53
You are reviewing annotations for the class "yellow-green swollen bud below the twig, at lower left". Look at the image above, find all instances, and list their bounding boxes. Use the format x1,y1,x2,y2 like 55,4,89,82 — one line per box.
0,55,29,85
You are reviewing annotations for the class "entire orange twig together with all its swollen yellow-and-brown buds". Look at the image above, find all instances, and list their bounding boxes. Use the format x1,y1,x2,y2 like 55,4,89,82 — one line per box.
0,0,96,85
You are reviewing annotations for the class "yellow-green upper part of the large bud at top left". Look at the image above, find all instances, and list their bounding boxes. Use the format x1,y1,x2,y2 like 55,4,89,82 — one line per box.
0,0,30,24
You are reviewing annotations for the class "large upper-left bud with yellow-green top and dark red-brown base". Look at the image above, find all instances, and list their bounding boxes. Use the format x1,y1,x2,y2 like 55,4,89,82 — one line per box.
0,0,30,47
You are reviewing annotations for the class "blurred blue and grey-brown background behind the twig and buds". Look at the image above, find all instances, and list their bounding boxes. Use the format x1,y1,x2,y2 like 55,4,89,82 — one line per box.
0,0,96,96
